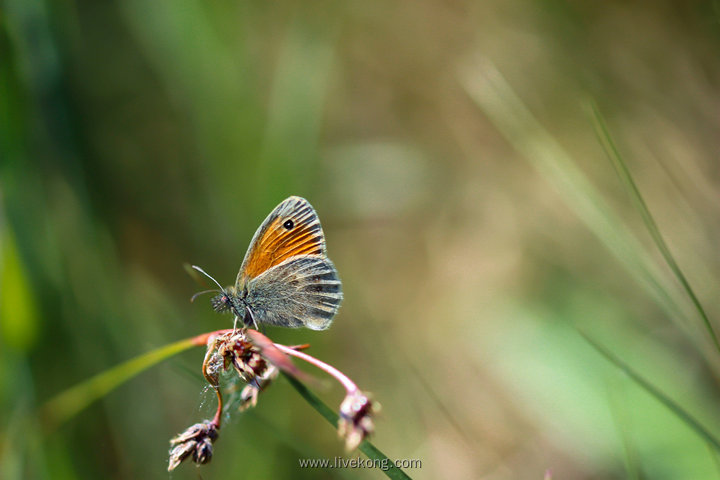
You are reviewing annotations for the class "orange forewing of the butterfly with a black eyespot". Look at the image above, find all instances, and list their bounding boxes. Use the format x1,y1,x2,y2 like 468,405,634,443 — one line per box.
236,197,326,286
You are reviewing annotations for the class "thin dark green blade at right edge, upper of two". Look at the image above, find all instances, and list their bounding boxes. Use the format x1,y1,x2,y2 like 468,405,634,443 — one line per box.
592,103,720,353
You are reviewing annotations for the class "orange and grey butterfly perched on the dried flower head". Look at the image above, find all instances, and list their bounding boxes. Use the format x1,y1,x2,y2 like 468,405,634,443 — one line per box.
192,196,343,330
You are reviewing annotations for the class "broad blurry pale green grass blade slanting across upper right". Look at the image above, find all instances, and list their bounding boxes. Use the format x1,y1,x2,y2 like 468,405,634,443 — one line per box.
460,60,705,343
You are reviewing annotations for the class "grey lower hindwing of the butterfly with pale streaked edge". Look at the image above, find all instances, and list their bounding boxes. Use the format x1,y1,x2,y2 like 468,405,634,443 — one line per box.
245,255,343,330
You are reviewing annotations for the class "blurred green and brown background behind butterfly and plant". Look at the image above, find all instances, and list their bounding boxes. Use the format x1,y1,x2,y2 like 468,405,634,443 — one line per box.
0,0,720,479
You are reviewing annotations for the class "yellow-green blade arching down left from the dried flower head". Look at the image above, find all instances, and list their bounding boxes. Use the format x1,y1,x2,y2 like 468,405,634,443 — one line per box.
40,338,197,431
